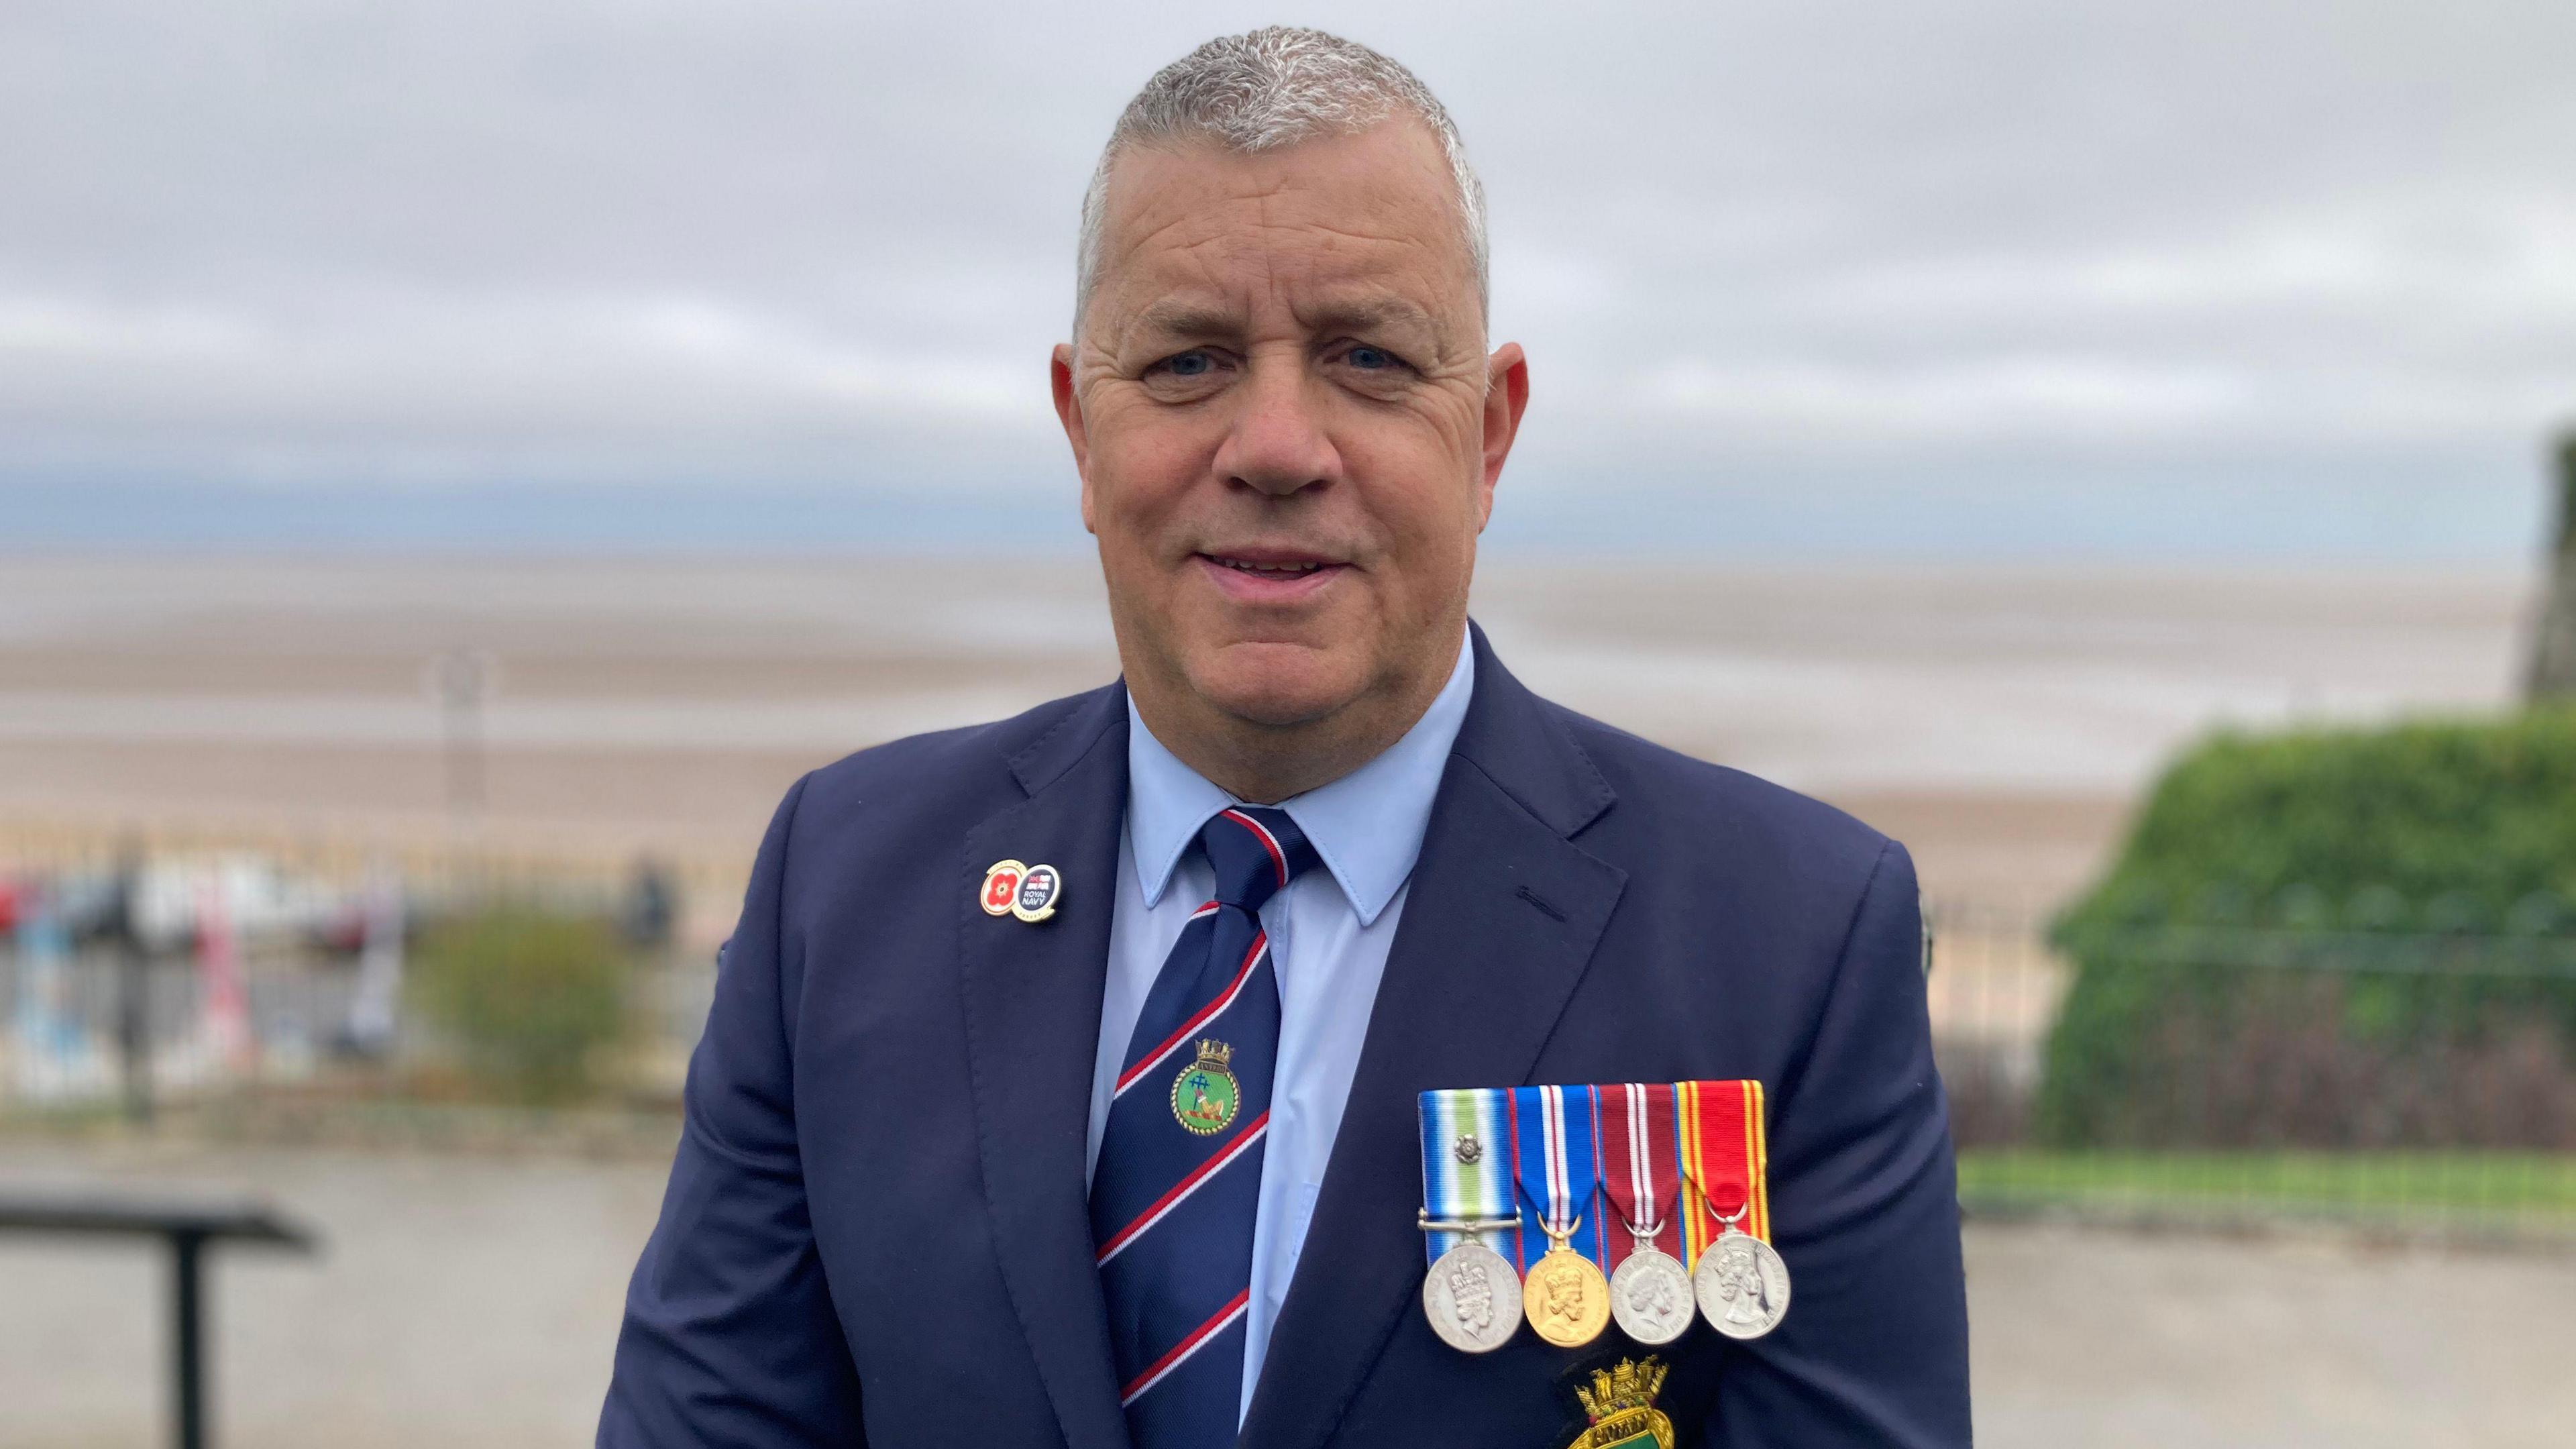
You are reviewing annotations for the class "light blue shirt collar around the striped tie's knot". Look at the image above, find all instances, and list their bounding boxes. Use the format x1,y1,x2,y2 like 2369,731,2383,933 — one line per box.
1128,631,1476,926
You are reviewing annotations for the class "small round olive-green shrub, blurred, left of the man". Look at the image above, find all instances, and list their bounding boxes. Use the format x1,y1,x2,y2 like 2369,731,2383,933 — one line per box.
415,905,626,1101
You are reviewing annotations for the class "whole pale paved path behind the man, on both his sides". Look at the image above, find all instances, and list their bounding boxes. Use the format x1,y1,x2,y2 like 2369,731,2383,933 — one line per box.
0,1140,2576,1449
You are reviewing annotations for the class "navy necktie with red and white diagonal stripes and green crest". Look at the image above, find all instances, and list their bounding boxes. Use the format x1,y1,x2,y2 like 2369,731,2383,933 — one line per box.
1092,804,1316,1449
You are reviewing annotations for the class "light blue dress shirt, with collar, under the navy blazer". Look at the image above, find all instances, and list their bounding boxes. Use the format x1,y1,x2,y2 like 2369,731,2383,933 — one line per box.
1087,629,1476,1413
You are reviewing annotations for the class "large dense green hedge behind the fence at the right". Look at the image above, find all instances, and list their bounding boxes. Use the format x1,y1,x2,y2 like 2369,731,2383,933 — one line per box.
2037,709,2576,1147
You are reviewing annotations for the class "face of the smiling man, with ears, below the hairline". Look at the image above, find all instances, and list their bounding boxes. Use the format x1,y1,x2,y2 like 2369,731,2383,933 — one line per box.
1054,119,1527,727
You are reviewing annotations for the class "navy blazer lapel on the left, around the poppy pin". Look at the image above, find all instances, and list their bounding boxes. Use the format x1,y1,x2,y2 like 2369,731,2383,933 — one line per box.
956,686,1128,1449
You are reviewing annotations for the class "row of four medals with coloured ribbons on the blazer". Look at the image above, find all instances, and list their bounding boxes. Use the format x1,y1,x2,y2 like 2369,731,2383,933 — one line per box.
1419,1080,1788,1354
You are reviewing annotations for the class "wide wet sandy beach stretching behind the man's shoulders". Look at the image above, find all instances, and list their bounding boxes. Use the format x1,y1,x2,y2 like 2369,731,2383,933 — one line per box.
0,554,2532,905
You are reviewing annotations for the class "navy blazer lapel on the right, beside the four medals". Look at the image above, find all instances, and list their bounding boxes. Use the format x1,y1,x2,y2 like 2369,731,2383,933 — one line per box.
1242,629,1628,1449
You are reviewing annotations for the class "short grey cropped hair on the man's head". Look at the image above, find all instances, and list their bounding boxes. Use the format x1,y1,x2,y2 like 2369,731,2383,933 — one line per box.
1074,25,1491,333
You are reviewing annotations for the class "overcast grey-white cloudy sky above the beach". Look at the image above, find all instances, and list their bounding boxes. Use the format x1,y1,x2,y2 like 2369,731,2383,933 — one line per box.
0,0,2576,557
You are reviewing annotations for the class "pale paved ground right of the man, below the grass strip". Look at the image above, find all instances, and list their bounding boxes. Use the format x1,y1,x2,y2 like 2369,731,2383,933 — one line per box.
1968,1225,2576,1449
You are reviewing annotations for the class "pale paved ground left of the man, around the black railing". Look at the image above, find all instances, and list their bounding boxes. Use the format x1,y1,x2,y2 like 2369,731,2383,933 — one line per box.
0,1142,662,1449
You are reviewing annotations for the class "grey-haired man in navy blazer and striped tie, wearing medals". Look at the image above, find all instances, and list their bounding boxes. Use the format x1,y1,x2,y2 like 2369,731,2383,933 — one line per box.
600,28,1968,1449
